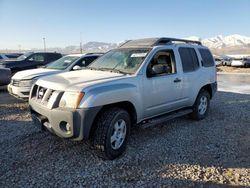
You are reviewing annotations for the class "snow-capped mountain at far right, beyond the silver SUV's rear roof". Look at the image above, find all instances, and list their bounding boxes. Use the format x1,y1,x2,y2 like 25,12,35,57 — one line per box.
187,34,250,49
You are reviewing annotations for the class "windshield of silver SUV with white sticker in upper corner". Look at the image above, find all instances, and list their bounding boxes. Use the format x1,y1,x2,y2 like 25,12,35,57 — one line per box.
88,49,150,74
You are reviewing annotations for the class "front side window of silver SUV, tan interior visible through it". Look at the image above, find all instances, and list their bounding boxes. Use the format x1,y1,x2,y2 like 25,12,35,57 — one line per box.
147,50,176,77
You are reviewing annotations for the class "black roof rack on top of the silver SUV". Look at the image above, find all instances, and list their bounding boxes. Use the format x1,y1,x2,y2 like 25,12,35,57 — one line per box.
120,37,202,48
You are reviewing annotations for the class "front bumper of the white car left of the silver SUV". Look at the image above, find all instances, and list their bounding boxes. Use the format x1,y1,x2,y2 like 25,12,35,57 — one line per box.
8,84,31,100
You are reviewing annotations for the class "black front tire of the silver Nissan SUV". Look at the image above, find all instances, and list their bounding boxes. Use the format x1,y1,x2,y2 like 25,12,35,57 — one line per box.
92,107,131,160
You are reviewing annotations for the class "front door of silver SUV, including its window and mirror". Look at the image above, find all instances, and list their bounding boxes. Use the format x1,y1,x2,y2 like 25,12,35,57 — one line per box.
143,50,183,118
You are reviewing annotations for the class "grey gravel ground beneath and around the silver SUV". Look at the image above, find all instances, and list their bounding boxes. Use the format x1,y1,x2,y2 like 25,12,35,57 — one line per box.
0,86,250,188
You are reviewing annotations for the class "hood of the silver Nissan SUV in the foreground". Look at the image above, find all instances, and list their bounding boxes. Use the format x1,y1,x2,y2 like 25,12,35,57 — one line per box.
36,70,125,91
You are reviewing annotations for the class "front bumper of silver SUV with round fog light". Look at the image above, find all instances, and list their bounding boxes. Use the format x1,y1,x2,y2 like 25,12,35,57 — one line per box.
29,99,101,140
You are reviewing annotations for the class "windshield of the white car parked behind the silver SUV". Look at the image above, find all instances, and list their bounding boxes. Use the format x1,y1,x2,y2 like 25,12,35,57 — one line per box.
46,56,80,70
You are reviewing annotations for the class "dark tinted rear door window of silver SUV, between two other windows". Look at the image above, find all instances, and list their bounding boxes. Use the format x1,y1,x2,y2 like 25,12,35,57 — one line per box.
179,48,199,72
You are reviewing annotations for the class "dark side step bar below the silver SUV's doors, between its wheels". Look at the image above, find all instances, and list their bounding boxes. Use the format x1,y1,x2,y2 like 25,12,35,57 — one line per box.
141,109,193,128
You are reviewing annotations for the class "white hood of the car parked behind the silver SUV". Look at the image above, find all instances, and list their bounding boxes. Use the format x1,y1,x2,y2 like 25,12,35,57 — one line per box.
12,68,62,80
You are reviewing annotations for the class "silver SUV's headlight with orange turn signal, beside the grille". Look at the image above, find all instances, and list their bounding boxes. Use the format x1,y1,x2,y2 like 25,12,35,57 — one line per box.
59,91,84,108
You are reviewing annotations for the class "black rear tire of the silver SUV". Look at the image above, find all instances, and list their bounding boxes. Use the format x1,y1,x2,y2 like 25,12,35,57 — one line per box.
190,89,210,120
